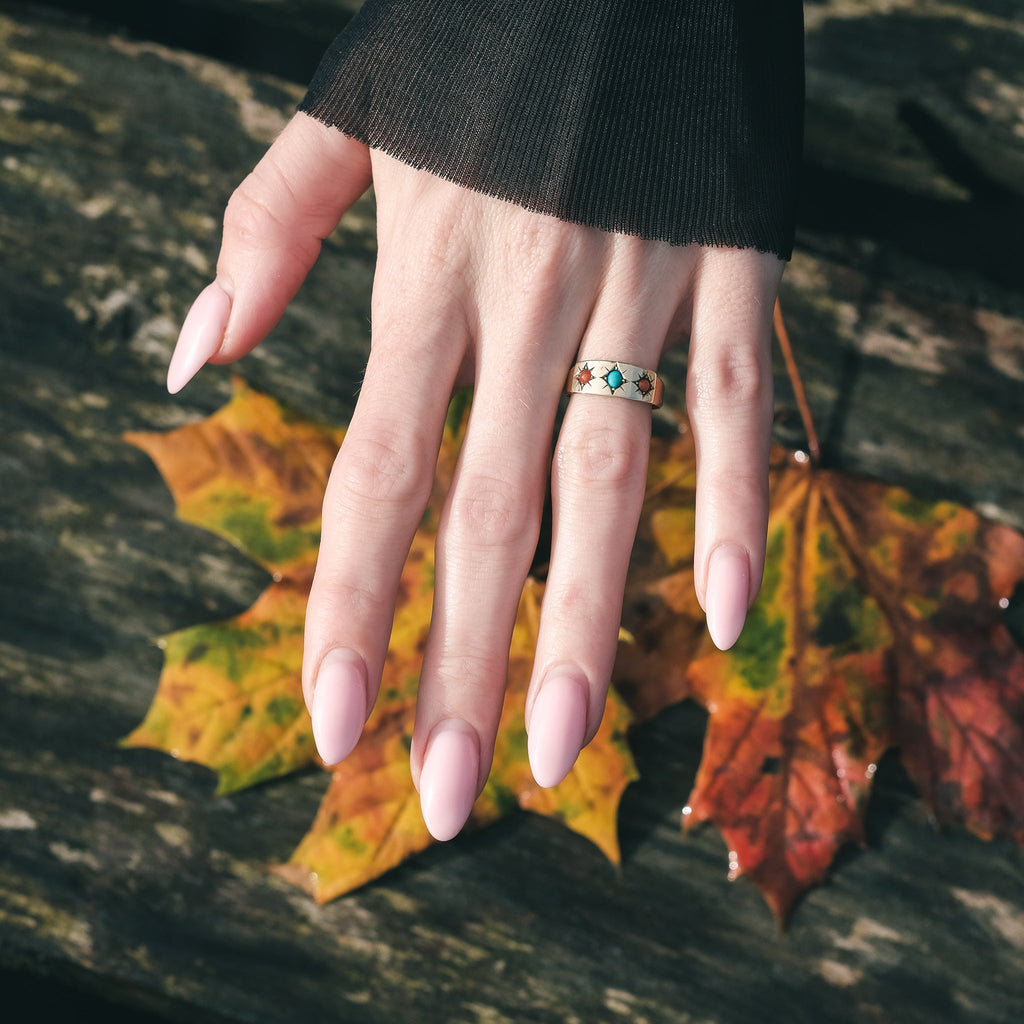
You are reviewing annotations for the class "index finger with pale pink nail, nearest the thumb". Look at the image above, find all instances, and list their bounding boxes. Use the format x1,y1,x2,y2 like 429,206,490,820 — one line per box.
303,292,465,764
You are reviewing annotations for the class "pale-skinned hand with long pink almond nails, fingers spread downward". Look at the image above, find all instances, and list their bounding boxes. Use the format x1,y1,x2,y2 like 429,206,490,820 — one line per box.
168,114,783,840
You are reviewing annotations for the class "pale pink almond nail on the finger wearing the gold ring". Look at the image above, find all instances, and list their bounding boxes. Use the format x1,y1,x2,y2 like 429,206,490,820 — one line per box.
527,673,587,788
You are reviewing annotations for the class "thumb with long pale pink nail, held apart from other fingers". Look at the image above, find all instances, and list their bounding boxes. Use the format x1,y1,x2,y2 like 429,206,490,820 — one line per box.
167,114,371,394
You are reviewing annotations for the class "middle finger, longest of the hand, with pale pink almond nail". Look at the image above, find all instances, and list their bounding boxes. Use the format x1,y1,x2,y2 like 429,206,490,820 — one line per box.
412,358,559,840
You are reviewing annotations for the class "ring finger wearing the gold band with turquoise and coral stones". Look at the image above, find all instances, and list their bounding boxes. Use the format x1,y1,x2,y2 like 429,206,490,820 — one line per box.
526,240,693,786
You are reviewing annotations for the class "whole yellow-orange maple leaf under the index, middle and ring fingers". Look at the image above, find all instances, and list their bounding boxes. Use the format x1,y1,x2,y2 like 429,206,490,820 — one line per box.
124,382,636,901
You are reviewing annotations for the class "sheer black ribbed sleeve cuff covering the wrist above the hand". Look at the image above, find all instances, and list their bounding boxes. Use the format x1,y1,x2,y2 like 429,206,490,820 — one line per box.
299,0,804,258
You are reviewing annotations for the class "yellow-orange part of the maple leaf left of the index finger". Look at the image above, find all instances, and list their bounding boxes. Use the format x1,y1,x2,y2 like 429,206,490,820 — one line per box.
123,381,344,793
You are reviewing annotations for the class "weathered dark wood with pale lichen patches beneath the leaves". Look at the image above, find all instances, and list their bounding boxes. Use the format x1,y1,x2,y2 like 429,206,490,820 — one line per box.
0,2,1024,1024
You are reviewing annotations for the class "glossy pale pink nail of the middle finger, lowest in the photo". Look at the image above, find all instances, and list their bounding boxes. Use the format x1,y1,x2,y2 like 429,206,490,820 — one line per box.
420,719,480,843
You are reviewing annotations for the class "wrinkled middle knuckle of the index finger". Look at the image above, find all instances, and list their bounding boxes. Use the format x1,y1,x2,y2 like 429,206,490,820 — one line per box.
334,436,433,505
